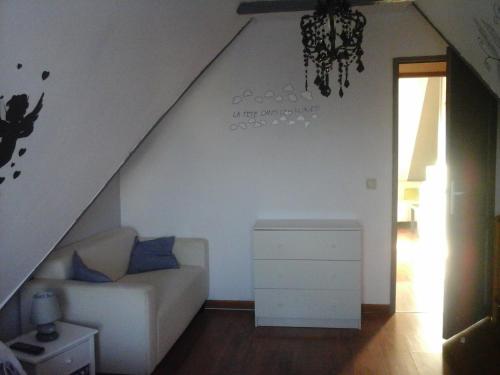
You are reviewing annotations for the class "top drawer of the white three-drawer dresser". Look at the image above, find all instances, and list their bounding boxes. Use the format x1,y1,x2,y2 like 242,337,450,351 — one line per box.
254,230,361,260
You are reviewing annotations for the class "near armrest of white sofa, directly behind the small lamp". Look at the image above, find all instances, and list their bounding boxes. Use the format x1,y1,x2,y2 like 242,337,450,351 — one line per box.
21,279,157,374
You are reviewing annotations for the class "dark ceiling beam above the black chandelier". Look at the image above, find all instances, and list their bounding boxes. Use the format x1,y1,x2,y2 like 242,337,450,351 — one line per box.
237,0,413,14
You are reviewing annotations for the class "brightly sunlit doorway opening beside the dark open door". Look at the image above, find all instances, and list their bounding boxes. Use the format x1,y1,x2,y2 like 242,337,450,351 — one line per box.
391,57,447,325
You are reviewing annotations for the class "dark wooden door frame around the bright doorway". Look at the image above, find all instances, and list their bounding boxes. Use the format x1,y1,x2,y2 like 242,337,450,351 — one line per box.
389,55,447,315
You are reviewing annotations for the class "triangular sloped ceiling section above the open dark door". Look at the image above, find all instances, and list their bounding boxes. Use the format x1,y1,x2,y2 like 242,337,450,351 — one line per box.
416,0,500,96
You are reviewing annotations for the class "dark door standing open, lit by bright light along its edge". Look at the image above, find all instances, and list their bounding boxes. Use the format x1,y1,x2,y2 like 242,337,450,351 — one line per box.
443,49,497,338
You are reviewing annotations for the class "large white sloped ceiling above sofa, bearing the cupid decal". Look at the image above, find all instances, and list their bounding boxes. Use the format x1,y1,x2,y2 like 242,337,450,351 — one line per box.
0,0,247,308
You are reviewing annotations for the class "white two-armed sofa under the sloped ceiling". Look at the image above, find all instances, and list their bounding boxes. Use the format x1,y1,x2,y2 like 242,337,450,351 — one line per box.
21,228,208,375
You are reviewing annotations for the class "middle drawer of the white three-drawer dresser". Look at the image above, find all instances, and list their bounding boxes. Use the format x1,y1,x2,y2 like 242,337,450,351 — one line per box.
254,259,361,290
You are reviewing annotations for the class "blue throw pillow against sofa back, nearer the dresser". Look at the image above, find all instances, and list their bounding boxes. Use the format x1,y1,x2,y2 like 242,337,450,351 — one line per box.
127,236,179,274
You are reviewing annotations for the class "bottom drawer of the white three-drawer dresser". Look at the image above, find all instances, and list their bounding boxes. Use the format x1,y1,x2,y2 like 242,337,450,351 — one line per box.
255,289,361,320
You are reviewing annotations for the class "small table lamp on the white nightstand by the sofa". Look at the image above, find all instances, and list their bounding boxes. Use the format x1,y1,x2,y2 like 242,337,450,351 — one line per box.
31,291,62,342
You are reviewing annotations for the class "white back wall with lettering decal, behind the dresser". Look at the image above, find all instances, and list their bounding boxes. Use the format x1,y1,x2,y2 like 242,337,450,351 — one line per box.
120,5,445,303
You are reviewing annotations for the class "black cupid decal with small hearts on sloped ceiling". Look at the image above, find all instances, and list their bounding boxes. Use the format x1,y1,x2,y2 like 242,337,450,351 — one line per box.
0,63,50,184
